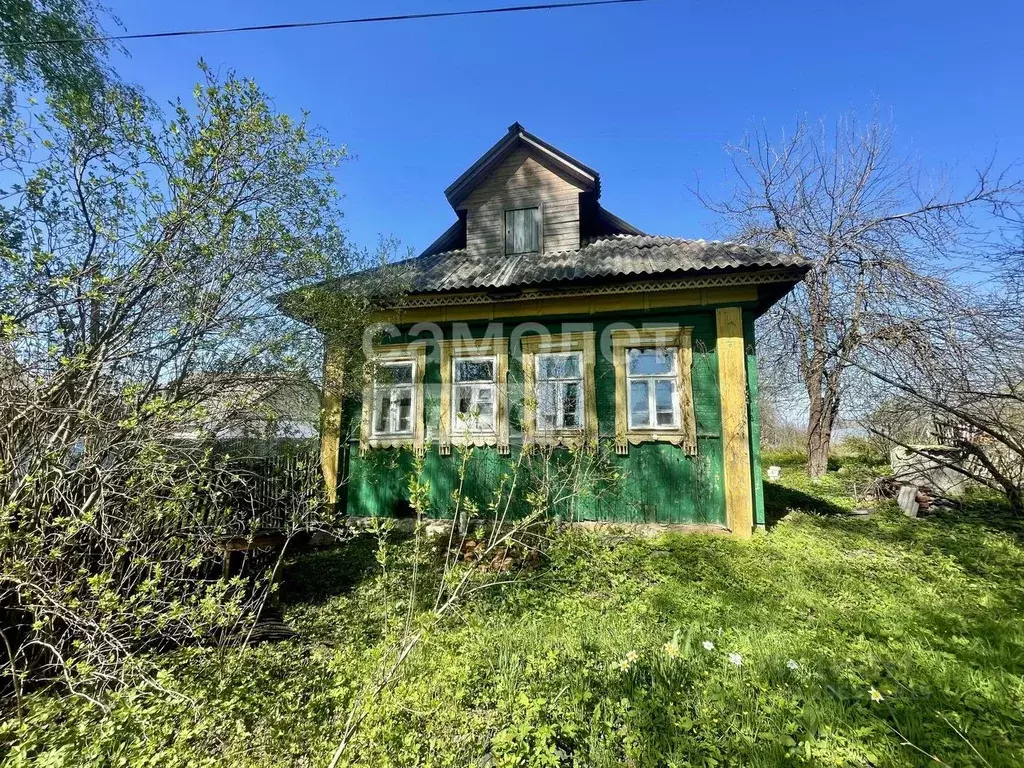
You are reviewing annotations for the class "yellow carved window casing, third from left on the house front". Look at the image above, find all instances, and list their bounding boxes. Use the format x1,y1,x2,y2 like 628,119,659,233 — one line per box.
522,331,597,445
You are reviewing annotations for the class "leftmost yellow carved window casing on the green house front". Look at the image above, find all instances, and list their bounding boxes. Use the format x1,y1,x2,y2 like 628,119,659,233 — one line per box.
359,343,427,454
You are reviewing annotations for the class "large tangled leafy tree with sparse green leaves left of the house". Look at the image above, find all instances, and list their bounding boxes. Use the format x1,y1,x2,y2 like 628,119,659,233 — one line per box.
0,66,385,691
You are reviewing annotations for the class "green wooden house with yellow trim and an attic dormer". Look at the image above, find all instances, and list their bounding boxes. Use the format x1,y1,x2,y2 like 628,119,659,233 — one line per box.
311,123,807,536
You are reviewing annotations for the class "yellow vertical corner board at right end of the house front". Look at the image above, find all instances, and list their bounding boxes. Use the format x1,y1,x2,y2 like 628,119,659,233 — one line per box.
715,306,754,538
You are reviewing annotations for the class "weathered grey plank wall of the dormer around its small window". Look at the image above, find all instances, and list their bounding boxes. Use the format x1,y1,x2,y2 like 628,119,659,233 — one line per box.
463,150,581,257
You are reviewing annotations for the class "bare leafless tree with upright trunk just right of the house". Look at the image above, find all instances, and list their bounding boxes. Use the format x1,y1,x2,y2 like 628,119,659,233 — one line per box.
698,116,1024,477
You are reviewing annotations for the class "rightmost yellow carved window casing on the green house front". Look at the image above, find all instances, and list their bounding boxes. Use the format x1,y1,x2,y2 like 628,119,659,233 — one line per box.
611,328,697,456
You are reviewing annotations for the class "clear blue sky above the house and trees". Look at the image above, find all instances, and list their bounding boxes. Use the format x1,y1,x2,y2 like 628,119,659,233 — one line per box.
97,0,1024,259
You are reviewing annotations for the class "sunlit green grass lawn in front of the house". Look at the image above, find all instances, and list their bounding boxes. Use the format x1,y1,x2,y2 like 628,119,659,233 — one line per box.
0,457,1024,766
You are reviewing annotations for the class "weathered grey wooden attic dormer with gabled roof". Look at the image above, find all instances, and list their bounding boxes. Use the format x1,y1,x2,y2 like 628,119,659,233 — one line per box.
444,123,600,256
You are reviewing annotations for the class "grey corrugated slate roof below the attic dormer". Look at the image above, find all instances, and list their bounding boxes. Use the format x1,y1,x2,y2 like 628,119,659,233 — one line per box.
376,234,807,293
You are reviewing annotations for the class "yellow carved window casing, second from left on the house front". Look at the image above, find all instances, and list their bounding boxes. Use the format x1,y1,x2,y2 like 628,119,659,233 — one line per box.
439,338,509,455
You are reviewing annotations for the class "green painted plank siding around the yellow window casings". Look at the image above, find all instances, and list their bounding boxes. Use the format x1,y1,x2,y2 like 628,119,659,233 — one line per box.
346,309,763,525
